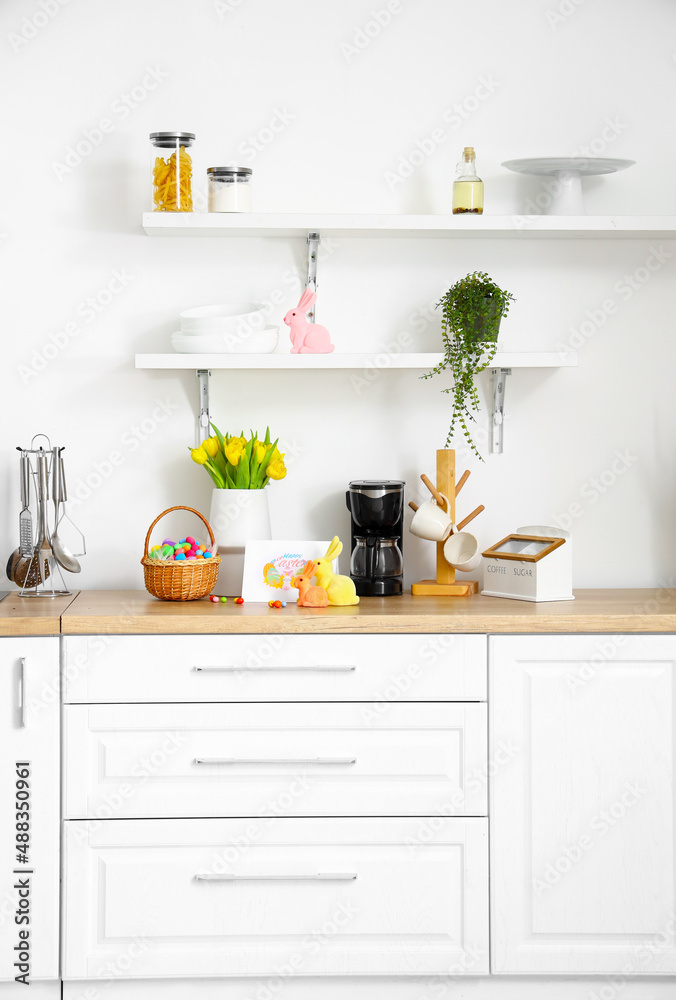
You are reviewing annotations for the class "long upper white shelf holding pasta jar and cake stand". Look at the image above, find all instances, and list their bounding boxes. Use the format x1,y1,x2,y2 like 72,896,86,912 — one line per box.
143,212,676,239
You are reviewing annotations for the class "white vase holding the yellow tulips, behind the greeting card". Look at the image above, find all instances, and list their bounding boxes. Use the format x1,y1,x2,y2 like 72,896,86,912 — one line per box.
209,489,272,597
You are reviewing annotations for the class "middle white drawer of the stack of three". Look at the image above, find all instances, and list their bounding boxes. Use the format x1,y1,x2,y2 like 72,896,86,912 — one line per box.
64,702,488,819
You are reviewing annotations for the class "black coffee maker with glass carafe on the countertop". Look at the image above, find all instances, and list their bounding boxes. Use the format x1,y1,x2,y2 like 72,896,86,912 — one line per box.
345,479,406,597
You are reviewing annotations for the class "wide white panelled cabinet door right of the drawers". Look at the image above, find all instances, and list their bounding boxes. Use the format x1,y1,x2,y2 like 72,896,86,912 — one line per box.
489,635,676,975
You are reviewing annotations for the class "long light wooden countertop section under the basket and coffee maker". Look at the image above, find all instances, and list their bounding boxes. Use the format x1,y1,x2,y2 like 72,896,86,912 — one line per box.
59,590,676,635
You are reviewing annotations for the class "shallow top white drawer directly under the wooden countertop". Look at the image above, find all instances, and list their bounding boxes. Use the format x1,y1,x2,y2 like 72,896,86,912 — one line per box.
63,634,487,707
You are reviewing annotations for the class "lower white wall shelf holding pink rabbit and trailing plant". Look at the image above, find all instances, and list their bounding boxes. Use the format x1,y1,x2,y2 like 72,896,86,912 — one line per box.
136,352,577,371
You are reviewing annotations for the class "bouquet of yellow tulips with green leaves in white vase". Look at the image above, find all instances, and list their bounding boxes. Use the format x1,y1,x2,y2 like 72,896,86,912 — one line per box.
190,424,286,490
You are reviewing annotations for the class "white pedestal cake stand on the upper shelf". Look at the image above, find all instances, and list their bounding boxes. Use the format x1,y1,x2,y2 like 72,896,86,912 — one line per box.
502,156,636,215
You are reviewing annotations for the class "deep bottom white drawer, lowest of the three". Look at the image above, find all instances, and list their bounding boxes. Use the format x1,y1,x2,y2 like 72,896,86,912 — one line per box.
63,819,488,979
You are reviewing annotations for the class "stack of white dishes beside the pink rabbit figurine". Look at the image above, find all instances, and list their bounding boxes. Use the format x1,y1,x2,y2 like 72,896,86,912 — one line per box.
171,302,279,354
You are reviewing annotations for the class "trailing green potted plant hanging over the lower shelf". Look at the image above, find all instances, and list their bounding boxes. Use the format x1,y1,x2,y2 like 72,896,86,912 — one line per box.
421,271,514,461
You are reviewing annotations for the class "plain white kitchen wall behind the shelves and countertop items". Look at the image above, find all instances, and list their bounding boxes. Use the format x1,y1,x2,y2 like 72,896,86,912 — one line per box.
0,0,676,588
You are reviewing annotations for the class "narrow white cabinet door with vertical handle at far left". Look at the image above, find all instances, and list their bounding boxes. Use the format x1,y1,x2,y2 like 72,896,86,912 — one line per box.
0,637,59,982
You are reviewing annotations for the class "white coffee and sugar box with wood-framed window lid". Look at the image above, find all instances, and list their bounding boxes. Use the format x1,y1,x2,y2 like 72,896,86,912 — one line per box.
481,524,574,601
